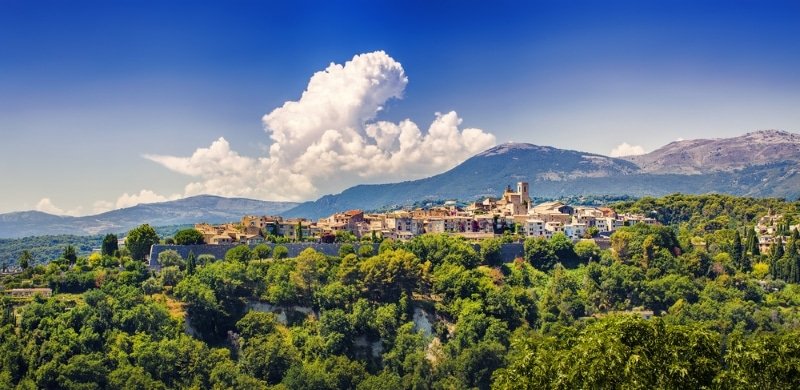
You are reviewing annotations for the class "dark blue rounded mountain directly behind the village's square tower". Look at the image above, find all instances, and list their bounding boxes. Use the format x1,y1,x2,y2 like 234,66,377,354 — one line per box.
284,143,638,219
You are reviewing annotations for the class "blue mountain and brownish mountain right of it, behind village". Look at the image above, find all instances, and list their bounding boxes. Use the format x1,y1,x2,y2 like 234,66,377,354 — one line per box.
284,130,800,218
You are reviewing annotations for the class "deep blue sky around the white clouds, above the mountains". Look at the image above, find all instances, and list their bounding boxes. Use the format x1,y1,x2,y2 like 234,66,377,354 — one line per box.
0,0,800,214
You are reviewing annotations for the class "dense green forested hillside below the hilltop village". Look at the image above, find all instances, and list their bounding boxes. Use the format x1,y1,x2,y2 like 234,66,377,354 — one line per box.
0,195,800,389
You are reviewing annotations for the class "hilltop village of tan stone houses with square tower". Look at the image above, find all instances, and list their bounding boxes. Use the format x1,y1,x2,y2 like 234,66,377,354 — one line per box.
195,182,657,245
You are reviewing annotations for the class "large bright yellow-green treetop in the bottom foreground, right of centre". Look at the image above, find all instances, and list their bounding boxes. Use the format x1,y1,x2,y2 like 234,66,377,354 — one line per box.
493,316,720,389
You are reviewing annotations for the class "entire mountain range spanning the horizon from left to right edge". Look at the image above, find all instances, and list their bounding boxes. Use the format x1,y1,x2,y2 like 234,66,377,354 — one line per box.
0,130,800,238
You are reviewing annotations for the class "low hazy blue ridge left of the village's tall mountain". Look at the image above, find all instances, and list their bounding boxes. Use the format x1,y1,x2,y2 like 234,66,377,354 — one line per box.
0,195,297,238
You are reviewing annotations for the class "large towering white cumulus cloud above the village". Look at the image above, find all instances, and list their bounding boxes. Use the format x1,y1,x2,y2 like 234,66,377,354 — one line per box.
144,51,496,200
